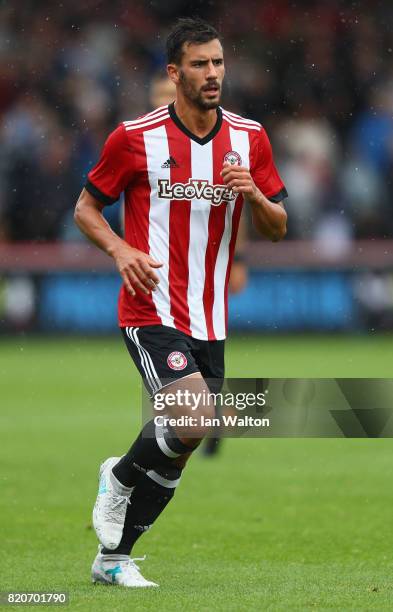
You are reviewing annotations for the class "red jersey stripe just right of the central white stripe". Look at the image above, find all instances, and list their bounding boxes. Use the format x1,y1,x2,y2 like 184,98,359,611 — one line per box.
203,126,231,340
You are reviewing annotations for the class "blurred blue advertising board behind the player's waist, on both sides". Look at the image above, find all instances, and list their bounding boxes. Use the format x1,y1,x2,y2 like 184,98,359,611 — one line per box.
0,245,393,334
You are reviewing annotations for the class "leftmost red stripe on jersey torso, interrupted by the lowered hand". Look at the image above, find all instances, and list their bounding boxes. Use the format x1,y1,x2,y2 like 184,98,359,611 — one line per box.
118,132,162,327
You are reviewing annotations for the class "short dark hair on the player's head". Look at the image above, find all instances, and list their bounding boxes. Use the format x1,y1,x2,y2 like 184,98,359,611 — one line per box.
166,17,221,65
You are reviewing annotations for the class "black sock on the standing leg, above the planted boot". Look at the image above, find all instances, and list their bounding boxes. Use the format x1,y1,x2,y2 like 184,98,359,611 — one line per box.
102,467,182,555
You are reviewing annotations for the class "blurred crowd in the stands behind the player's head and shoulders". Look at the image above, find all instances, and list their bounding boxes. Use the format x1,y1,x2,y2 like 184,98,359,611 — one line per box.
0,0,393,249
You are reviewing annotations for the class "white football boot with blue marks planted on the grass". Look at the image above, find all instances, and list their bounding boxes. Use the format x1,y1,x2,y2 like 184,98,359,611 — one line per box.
91,546,158,588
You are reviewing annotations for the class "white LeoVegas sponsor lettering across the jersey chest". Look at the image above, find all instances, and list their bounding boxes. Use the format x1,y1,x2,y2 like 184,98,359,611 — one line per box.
157,179,236,206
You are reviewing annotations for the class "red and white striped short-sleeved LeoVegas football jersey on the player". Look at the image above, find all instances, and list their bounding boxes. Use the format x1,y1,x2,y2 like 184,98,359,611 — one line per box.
86,103,287,340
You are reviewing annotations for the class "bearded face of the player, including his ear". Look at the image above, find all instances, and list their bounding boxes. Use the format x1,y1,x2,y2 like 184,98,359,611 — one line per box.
168,39,225,110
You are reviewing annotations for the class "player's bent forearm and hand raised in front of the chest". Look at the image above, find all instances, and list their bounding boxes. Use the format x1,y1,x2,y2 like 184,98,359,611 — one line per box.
221,164,287,242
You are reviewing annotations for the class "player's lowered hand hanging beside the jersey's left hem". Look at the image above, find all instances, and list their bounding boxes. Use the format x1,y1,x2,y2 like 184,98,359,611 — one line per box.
113,243,163,296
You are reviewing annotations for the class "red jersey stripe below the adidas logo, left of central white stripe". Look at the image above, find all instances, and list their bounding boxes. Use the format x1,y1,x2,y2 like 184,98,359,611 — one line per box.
165,121,191,335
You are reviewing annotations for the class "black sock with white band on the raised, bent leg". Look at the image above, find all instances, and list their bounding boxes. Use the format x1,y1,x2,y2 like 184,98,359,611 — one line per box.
112,420,193,487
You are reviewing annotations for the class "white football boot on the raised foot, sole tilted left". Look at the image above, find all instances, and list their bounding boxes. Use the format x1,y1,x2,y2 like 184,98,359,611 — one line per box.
93,457,133,550
